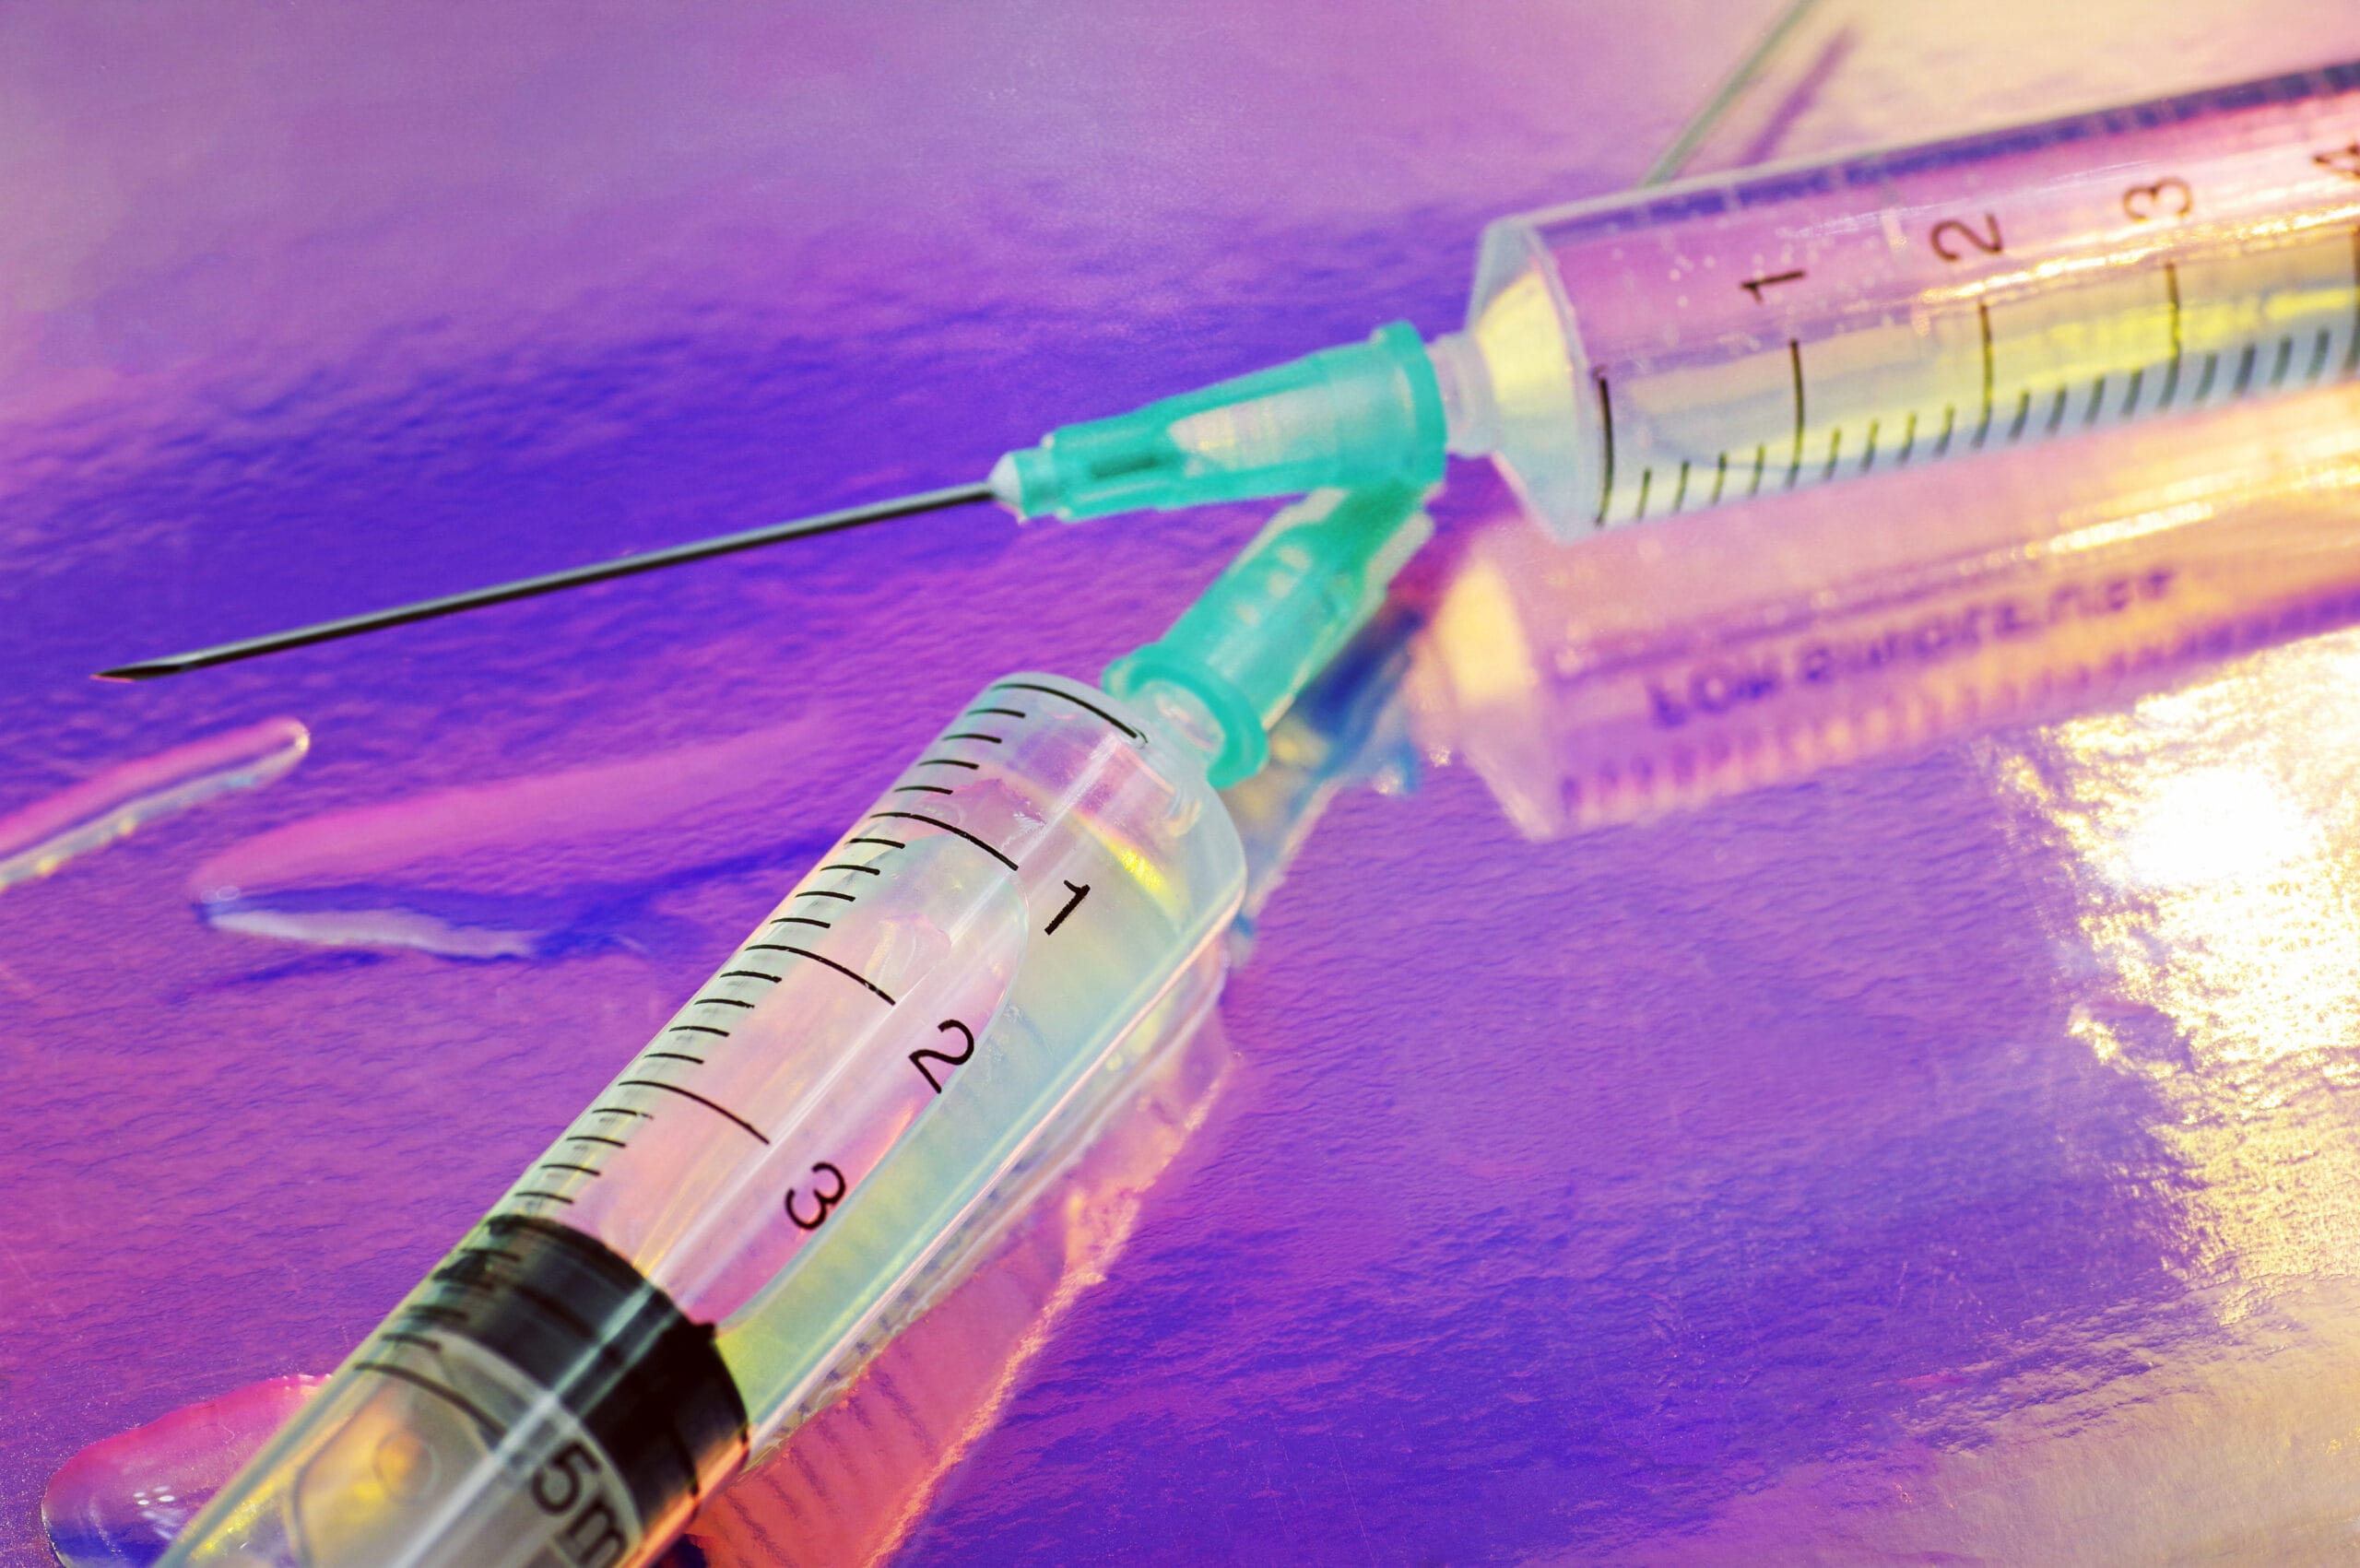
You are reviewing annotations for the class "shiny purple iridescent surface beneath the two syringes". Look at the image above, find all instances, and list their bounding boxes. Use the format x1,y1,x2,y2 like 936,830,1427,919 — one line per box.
14,0,2360,1568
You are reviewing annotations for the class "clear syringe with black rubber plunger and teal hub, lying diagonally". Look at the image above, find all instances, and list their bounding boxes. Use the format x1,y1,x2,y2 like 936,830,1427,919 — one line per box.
163,489,1430,1568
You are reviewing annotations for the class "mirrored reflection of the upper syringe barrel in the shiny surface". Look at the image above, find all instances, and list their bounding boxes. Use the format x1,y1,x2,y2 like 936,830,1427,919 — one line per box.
1407,375,2360,838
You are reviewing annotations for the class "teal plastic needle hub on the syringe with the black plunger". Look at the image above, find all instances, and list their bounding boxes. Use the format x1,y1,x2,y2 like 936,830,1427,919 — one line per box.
1100,484,1434,789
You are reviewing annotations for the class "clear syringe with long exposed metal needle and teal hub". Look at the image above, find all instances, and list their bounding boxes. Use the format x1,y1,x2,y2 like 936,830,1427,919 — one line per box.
106,64,2360,678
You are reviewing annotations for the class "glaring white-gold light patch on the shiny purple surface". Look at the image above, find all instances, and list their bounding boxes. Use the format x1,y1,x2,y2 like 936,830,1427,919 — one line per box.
2001,633,2360,1315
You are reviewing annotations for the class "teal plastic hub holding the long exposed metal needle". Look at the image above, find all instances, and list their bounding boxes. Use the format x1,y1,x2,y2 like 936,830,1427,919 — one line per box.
991,321,1446,522
